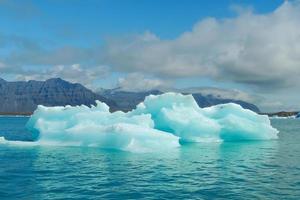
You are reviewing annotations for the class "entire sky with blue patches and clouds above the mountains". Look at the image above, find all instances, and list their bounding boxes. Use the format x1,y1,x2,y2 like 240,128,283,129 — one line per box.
0,0,300,111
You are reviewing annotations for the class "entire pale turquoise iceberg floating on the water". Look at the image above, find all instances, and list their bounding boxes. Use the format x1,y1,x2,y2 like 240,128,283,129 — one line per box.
26,93,278,151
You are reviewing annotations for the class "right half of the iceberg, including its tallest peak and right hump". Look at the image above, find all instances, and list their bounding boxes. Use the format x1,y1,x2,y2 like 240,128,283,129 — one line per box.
131,93,278,142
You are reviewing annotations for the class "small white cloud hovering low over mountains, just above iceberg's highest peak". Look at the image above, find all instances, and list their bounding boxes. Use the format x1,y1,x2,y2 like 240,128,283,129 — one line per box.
118,73,170,92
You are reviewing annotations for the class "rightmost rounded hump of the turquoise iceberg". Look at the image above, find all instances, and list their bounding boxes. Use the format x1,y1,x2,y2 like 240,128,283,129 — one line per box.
203,103,278,141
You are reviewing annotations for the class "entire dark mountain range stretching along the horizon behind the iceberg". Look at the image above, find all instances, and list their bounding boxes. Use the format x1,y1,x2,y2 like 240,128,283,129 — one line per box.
0,78,259,114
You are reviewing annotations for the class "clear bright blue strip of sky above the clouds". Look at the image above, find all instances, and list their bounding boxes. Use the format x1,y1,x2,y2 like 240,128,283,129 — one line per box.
0,0,282,46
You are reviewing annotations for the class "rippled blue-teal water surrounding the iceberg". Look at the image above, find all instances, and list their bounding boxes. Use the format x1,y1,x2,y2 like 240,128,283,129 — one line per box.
0,117,300,200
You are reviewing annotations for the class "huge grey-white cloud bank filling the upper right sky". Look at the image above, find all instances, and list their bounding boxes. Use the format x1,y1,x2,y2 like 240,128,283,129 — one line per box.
105,1,300,90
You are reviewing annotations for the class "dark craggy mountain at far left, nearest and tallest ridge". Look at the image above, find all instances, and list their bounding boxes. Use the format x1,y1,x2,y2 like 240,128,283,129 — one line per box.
0,78,116,114
